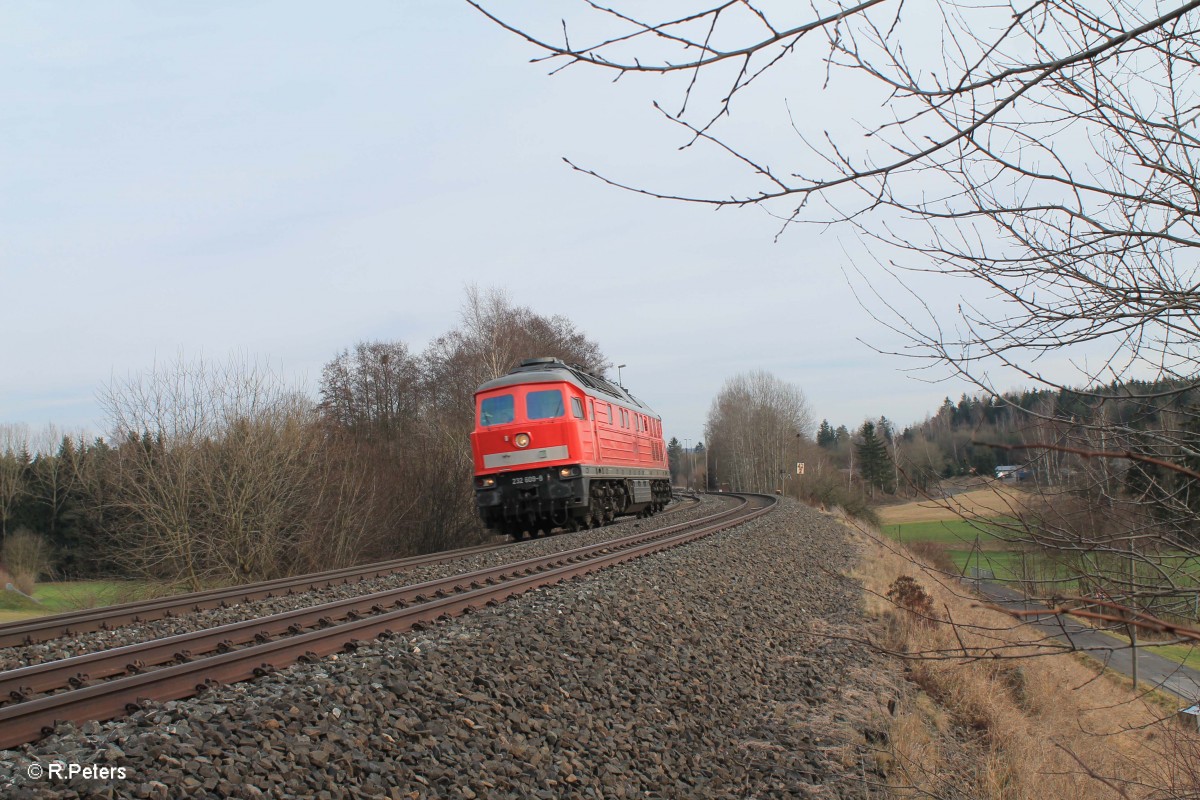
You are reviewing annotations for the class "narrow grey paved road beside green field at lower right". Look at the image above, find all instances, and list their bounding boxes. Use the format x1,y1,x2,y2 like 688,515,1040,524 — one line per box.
967,581,1200,703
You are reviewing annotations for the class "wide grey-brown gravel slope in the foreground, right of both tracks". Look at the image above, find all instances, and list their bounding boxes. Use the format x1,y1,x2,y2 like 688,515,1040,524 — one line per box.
0,503,893,799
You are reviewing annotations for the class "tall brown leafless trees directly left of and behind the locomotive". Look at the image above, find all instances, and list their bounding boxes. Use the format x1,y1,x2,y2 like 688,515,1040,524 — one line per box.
320,287,605,552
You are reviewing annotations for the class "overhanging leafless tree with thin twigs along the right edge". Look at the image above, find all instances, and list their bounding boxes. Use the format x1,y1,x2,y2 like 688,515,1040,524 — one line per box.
468,0,1200,603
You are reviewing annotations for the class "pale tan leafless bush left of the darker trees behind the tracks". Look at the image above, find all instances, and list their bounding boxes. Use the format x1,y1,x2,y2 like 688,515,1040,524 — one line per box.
99,357,374,588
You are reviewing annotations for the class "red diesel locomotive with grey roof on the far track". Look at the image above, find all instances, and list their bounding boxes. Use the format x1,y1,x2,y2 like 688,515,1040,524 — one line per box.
470,359,671,536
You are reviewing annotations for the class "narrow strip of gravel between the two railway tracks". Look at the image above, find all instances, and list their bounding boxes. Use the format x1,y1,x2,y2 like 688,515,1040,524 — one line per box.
0,498,725,672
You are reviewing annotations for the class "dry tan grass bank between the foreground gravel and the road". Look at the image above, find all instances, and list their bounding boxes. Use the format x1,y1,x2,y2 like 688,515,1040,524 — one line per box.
856,522,1200,800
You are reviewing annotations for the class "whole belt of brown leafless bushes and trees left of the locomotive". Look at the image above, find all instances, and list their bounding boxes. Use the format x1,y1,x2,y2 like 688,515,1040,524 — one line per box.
0,288,605,589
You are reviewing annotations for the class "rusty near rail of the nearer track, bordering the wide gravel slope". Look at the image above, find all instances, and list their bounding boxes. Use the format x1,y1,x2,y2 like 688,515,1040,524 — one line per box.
0,495,775,748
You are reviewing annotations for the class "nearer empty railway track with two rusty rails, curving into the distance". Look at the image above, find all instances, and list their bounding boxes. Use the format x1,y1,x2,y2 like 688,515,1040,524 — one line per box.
0,495,775,748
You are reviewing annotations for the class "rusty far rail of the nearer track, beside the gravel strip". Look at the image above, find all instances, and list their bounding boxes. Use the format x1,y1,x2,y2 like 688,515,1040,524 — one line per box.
0,501,729,702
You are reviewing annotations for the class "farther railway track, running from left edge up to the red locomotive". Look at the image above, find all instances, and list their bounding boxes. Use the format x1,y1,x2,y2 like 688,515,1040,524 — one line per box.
0,498,694,648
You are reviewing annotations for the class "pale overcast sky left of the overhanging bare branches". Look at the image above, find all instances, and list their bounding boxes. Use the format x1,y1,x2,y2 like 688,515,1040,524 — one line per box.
0,0,984,441
